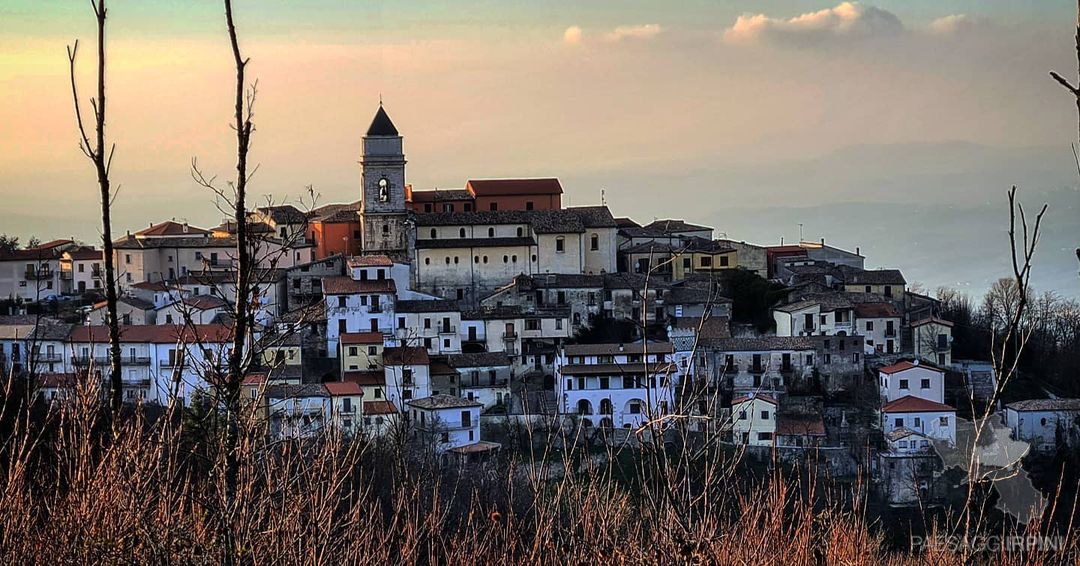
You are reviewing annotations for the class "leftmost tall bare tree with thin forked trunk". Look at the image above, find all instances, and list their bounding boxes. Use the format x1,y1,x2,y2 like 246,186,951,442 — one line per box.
68,0,124,413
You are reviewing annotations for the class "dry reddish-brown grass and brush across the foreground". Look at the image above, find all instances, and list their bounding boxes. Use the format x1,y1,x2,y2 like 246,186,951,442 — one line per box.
0,382,1077,565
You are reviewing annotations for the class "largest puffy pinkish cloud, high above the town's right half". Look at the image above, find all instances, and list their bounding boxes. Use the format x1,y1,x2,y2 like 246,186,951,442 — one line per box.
724,2,904,44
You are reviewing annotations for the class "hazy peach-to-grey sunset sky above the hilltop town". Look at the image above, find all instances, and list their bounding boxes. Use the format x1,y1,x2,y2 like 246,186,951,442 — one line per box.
0,0,1080,295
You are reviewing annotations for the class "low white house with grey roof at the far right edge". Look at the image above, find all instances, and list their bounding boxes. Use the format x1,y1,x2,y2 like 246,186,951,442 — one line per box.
1005,399,1080,452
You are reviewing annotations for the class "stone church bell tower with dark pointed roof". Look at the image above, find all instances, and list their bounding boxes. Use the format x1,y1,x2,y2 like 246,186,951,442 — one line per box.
360,102,409,262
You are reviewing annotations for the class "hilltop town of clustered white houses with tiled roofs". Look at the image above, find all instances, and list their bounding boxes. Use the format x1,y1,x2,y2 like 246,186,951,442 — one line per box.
0,105,1080,506
